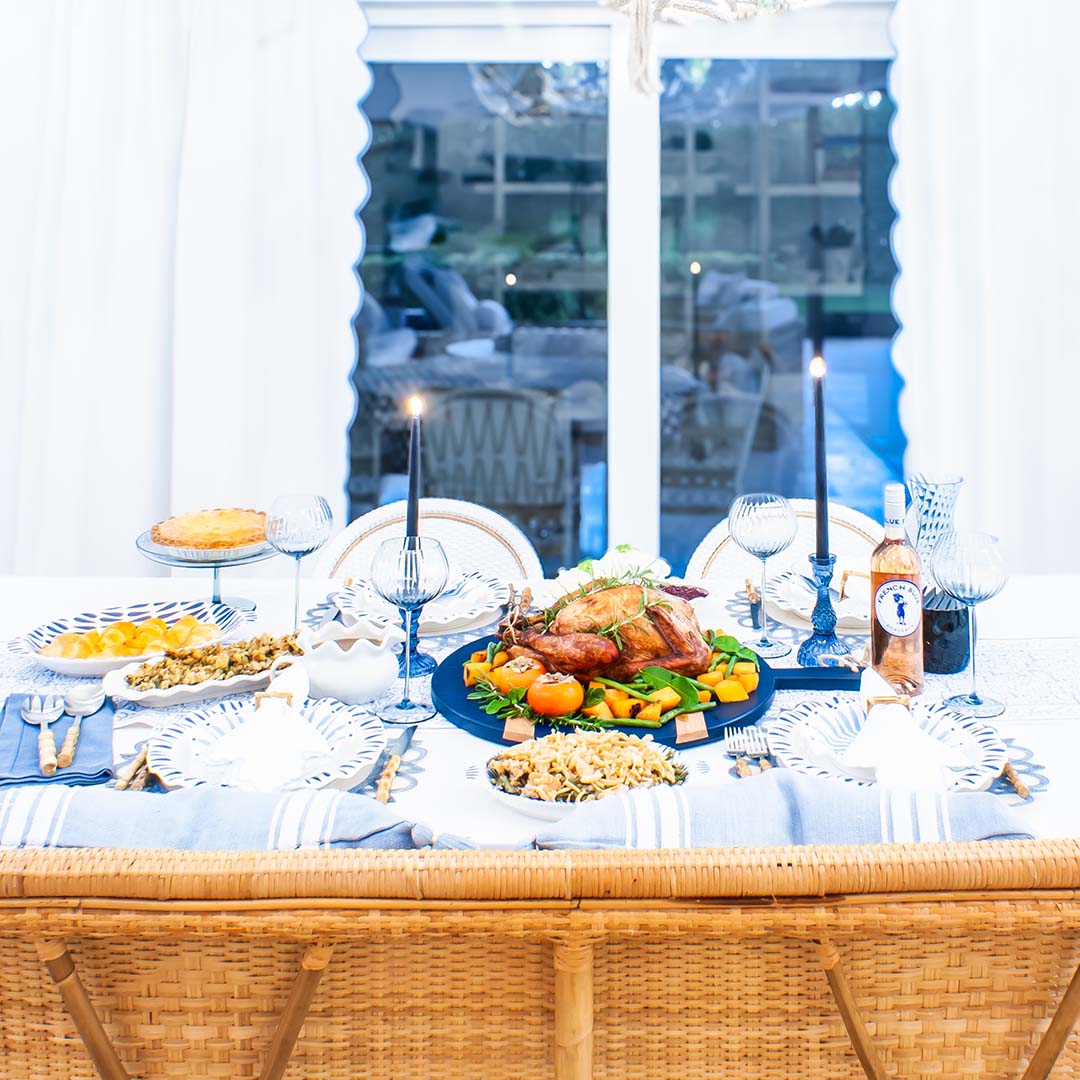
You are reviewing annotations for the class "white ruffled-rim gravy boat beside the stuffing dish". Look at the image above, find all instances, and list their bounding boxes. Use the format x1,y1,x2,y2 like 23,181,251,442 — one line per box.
271,615,405,705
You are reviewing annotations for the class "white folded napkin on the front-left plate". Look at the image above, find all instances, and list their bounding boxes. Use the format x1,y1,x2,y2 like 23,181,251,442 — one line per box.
205,699,334,792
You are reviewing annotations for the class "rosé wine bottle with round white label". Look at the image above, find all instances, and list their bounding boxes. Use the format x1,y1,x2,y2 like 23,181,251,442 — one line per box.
870,484,922,694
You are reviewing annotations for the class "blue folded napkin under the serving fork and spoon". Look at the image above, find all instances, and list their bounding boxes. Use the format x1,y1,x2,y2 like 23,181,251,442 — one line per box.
0,693,116,787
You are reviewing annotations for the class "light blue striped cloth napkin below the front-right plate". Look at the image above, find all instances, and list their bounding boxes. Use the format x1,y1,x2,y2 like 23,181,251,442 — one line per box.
535,769,1030,849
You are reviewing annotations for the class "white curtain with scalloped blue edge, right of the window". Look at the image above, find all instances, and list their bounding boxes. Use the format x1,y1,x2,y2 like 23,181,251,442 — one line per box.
891,0,1080,571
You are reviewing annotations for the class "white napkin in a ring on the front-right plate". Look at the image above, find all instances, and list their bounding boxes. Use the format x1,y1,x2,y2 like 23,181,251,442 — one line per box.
840,669,964,792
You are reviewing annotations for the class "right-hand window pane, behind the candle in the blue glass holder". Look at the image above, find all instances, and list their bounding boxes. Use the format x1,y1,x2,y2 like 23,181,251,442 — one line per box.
660,59,905,569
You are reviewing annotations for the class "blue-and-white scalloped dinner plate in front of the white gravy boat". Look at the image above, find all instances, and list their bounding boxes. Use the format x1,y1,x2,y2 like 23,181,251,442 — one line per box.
148,698,387,791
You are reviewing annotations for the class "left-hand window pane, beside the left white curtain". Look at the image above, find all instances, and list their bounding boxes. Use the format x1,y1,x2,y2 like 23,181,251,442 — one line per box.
349,64,607,570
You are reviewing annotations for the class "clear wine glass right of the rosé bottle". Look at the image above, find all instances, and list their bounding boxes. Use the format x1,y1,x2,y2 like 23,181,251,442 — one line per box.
930,532,1007,718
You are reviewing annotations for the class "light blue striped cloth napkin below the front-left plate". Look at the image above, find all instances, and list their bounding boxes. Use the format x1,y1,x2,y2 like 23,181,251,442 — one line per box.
0,784,468,851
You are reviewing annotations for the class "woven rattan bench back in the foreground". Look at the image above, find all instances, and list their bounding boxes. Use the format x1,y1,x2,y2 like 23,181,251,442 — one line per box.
0,841,1080,1080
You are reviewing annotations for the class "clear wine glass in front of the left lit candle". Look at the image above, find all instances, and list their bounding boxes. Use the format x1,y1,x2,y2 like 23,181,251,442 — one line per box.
372,537,449,724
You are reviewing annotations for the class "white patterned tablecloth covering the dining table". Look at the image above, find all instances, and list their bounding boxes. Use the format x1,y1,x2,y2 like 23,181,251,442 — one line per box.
0,568,1080,846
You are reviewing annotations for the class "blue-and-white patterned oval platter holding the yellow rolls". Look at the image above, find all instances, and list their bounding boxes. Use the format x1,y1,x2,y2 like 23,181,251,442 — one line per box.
22,600,251,678
